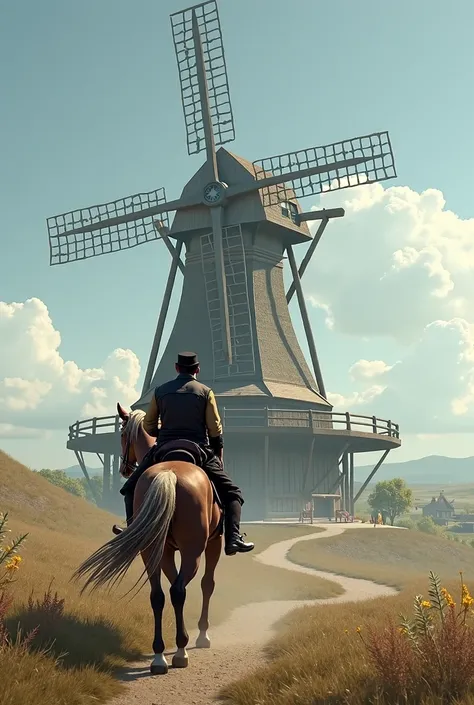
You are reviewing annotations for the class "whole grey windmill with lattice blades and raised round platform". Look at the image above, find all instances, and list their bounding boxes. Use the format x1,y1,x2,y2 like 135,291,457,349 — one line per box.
48,0,400,517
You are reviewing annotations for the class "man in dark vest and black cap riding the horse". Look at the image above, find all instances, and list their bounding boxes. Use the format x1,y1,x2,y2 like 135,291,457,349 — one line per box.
113,352,254,556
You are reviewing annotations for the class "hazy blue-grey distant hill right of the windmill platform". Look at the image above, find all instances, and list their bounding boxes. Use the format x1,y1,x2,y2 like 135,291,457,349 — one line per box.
355,455,474,486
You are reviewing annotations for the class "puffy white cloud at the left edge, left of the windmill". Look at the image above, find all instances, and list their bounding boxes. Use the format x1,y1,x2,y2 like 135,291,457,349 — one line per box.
0,298,140,438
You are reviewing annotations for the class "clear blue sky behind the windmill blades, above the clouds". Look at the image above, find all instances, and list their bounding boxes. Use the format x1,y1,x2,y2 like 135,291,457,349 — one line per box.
0,0,474,464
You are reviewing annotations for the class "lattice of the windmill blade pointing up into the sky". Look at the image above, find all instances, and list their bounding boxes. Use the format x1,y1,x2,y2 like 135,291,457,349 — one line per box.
171,0,235,154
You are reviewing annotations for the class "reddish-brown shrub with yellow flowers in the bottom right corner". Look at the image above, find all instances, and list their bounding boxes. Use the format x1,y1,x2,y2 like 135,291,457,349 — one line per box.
357,573,474,703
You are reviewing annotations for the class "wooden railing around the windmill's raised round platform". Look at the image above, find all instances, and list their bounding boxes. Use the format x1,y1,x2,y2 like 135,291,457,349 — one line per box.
69,407,400,440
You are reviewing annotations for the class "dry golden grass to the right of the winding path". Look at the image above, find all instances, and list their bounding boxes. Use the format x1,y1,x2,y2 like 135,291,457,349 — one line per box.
222,528,474,705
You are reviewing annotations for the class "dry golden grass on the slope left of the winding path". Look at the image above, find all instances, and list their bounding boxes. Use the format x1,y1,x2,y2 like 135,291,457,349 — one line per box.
0,451,341,705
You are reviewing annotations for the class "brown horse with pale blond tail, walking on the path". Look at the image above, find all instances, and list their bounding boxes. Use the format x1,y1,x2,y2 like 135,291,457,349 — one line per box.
74,404,222,675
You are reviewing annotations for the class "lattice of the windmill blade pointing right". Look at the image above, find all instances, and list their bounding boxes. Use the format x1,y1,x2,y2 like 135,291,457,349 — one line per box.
253,132,397,206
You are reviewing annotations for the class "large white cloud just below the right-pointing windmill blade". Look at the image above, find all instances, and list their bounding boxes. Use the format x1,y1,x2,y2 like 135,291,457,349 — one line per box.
305,184,474,343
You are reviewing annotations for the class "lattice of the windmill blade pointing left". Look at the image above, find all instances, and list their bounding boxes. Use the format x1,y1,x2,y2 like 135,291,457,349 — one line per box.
47,188,168,265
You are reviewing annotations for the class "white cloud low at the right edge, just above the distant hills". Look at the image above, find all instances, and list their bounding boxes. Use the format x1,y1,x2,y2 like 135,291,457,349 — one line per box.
331,318,474,434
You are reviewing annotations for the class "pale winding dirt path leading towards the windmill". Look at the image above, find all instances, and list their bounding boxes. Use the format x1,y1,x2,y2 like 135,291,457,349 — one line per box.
110,524,396,705
